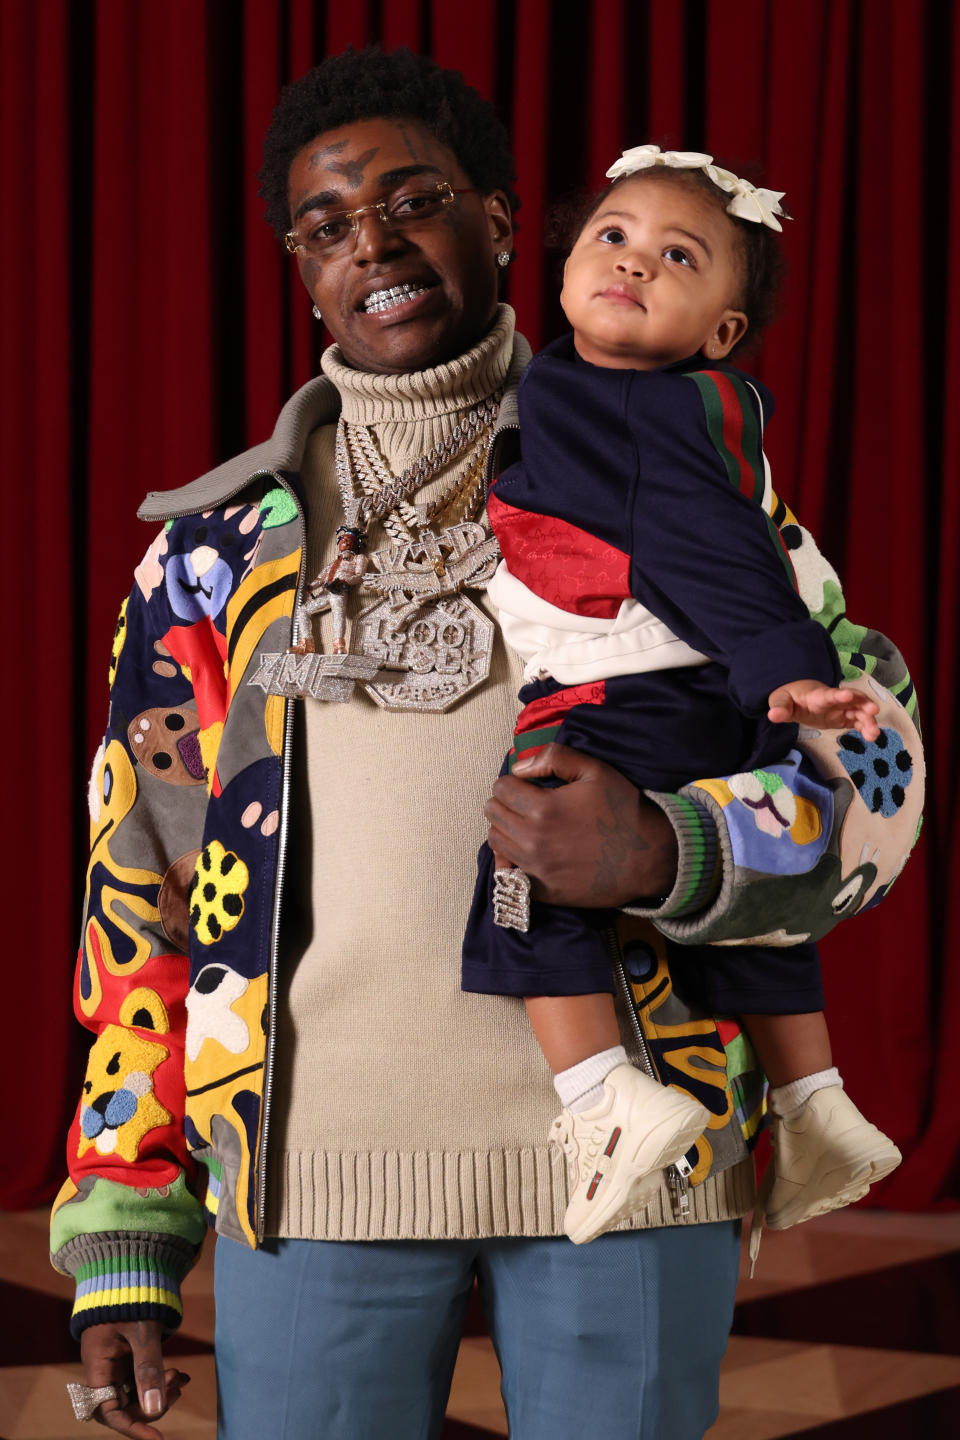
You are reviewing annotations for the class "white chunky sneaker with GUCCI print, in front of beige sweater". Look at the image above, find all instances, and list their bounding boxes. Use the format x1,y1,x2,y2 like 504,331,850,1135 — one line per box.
550,1066,710,1246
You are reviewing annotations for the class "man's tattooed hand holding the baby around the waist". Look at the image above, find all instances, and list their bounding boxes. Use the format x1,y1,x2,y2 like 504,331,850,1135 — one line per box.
485,744,678,909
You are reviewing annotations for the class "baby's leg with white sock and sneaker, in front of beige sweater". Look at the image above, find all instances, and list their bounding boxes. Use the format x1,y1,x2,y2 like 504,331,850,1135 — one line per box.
525,992,710,1244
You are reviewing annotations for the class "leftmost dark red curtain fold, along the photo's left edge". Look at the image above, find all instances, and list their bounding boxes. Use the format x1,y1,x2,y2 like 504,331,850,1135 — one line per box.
0,0,86,1208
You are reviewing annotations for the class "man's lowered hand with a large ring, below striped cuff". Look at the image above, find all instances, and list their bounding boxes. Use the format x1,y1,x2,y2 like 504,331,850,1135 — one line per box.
81,1320,190,1440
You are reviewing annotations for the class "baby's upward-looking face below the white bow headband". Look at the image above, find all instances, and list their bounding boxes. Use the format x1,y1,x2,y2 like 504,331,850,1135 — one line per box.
560,176,747,370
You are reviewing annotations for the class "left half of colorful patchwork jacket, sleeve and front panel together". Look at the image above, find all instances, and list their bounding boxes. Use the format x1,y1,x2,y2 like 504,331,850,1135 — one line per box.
52,477,299,1333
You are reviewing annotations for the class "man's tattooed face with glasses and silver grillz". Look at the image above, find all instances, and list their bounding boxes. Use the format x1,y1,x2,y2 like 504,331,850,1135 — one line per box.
288,118,512,374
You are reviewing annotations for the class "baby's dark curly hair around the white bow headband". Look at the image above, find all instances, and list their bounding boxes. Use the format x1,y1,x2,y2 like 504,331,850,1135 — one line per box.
547,161,786,359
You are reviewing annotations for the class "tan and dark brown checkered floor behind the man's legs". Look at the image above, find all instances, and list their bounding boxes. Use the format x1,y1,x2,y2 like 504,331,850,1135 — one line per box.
0,1211,960,1440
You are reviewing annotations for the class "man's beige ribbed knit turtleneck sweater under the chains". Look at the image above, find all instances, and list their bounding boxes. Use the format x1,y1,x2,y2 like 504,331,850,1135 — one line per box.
268,307,750,1240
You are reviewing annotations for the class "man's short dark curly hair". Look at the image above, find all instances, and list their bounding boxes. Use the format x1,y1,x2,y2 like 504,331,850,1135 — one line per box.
258,45,520,239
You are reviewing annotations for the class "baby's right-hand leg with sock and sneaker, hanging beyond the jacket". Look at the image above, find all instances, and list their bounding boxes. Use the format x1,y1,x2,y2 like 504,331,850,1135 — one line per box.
741,1011,901,1230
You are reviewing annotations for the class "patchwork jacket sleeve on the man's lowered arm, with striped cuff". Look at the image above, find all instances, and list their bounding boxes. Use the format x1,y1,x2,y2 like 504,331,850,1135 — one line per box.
52,527,216,1333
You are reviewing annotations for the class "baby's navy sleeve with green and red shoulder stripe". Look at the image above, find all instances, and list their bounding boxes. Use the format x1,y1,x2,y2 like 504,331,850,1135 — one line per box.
625,370,841,714
